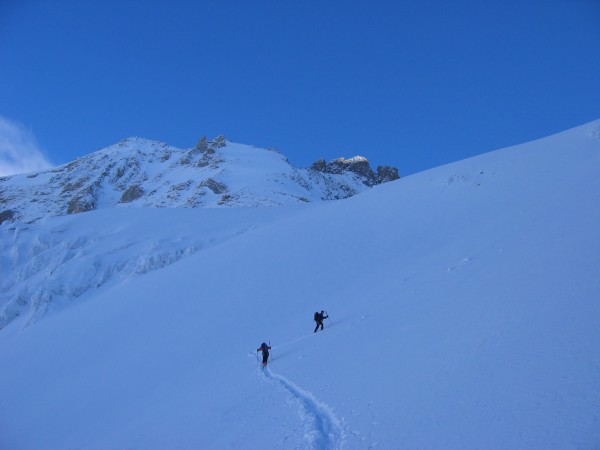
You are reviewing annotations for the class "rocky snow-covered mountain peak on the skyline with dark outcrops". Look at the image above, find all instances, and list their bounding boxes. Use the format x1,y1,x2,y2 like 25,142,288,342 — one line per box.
0,137,399,223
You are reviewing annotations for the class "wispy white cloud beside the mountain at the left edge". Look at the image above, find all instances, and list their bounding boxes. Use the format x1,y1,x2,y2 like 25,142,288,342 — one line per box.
0,116,53,176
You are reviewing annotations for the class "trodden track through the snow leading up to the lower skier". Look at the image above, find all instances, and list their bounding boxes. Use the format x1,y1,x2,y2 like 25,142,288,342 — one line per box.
263,367,344,450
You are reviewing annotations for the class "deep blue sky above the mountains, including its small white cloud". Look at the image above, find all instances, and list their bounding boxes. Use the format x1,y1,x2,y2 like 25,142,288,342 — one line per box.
0,0,600,175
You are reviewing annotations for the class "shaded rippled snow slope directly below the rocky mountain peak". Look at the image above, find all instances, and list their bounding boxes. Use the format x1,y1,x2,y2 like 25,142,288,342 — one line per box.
0,208,296,329
